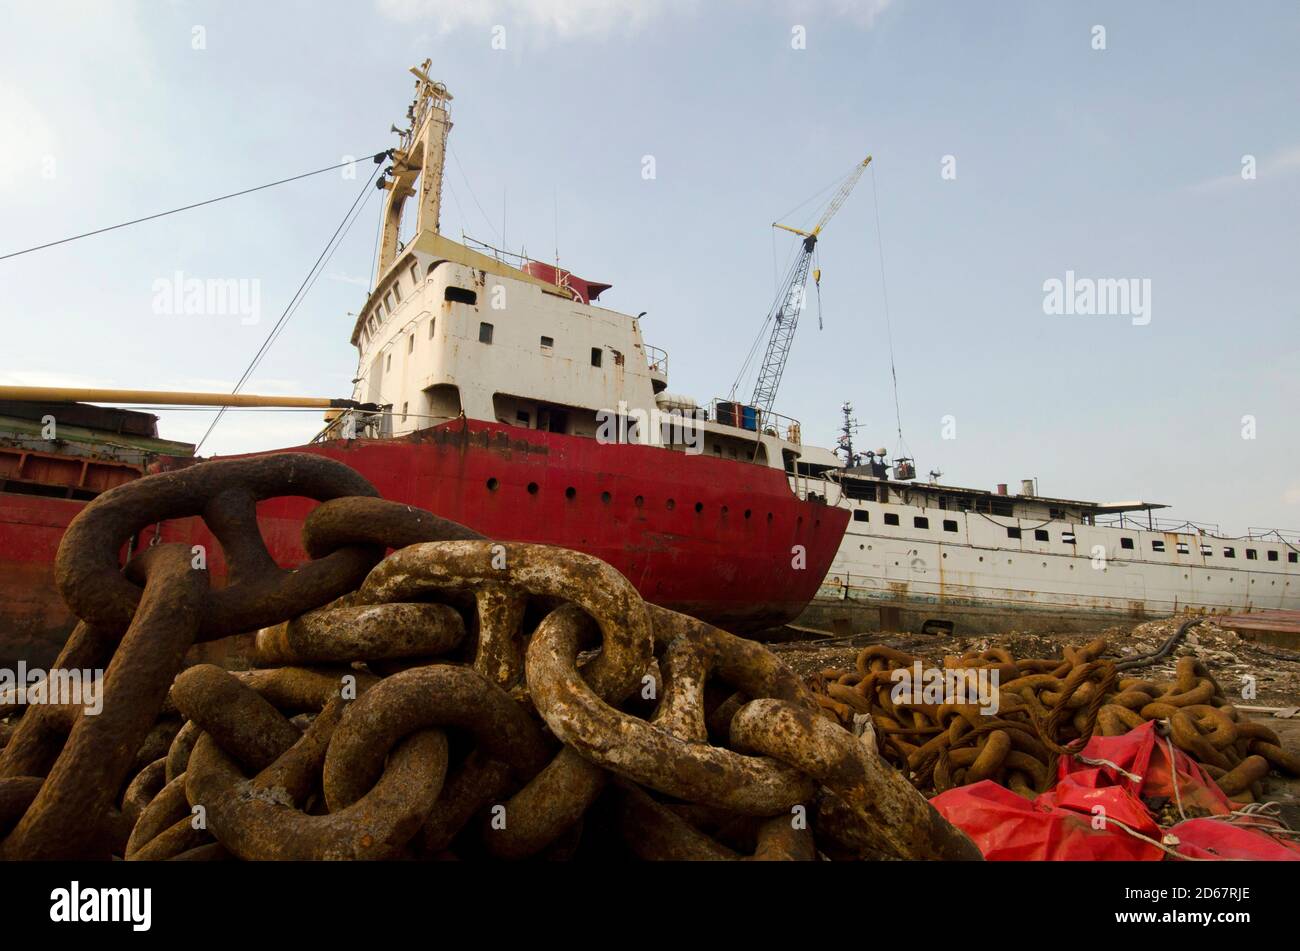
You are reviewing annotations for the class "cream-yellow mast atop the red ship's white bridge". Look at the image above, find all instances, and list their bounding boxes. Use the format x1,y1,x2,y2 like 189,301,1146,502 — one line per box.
376,60,452,279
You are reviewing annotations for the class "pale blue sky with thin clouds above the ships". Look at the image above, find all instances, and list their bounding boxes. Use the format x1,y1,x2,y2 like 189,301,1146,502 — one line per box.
0,0,1300,534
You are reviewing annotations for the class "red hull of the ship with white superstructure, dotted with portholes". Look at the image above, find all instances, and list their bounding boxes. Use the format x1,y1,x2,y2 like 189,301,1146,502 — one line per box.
0,421,849,664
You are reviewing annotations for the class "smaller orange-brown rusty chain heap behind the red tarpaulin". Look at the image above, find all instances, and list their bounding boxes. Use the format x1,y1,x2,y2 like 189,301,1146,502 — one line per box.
809,639,1300,803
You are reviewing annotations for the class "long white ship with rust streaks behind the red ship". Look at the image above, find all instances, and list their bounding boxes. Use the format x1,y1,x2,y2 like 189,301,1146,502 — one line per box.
790,415,1300,634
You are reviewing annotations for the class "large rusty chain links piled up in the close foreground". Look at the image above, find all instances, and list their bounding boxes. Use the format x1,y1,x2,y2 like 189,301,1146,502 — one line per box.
0,453,980,860
